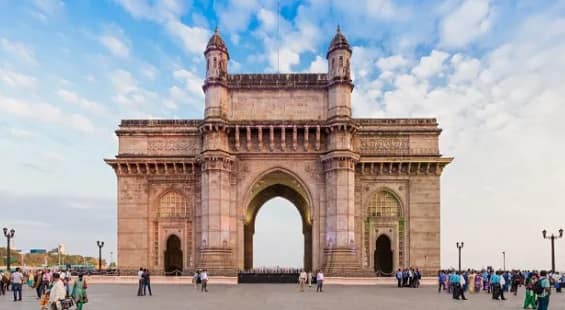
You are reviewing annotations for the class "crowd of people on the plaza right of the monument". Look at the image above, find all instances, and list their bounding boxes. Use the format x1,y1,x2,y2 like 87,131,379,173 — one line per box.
438,268,565,310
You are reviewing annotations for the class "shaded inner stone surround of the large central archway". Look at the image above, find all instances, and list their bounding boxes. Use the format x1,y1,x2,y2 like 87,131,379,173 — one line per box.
243,168,312,270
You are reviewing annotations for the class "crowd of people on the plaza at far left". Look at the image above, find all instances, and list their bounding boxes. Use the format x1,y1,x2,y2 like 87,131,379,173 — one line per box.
0,268,88,310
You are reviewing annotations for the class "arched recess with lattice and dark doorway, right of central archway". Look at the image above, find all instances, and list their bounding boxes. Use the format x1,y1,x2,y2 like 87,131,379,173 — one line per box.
364,187,407,275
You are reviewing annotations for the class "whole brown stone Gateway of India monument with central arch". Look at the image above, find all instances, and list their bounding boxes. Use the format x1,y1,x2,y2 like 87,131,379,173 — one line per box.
106,28,452,276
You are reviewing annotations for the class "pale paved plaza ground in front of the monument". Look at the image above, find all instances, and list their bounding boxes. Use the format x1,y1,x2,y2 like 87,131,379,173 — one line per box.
0,284,565,310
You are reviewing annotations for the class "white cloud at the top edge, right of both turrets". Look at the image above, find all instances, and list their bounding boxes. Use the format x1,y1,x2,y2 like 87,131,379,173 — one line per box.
440,0,494,48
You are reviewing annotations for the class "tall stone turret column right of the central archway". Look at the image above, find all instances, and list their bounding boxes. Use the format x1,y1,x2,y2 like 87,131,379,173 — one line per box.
321,26,360,275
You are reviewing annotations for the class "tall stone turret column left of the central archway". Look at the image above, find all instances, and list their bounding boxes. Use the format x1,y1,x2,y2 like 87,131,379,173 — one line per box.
197,29,237,274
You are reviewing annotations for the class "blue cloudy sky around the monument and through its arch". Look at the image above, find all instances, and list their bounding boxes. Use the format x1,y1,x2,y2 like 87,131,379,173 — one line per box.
0,0,565,269
